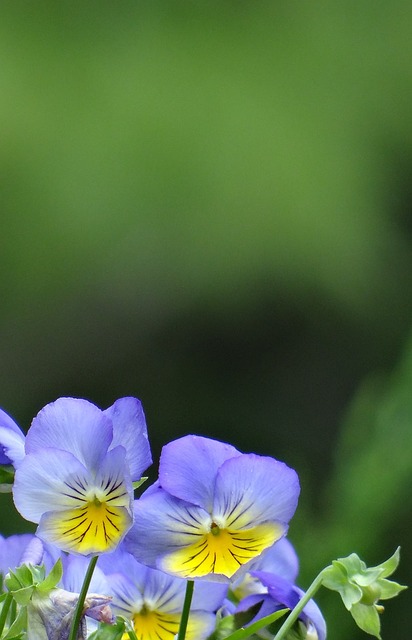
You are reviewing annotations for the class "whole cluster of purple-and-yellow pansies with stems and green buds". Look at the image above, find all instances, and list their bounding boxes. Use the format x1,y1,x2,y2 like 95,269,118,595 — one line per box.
0,397,402,640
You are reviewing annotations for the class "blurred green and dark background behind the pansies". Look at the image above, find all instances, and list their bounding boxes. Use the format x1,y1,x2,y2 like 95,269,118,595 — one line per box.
0,0,412,640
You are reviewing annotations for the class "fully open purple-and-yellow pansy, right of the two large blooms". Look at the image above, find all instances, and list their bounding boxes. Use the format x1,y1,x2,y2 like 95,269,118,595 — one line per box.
126,435,299,580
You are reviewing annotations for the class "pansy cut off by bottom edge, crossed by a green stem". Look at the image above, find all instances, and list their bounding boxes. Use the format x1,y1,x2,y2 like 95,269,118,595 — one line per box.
99,548,227,640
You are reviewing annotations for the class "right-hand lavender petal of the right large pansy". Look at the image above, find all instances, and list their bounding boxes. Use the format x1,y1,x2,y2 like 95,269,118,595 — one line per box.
213,454,300,529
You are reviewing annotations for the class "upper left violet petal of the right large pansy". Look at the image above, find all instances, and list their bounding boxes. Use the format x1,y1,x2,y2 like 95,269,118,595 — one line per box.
159,435,242,511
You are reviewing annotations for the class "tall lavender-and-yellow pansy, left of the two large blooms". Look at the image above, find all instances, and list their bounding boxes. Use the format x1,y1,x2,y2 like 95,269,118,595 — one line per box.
13,398,151,555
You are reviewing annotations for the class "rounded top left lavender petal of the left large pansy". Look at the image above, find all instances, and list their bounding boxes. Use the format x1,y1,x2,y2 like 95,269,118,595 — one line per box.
26,398,113,470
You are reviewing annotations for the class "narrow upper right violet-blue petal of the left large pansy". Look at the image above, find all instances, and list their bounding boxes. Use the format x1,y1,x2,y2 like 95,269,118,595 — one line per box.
103,397,152,481
